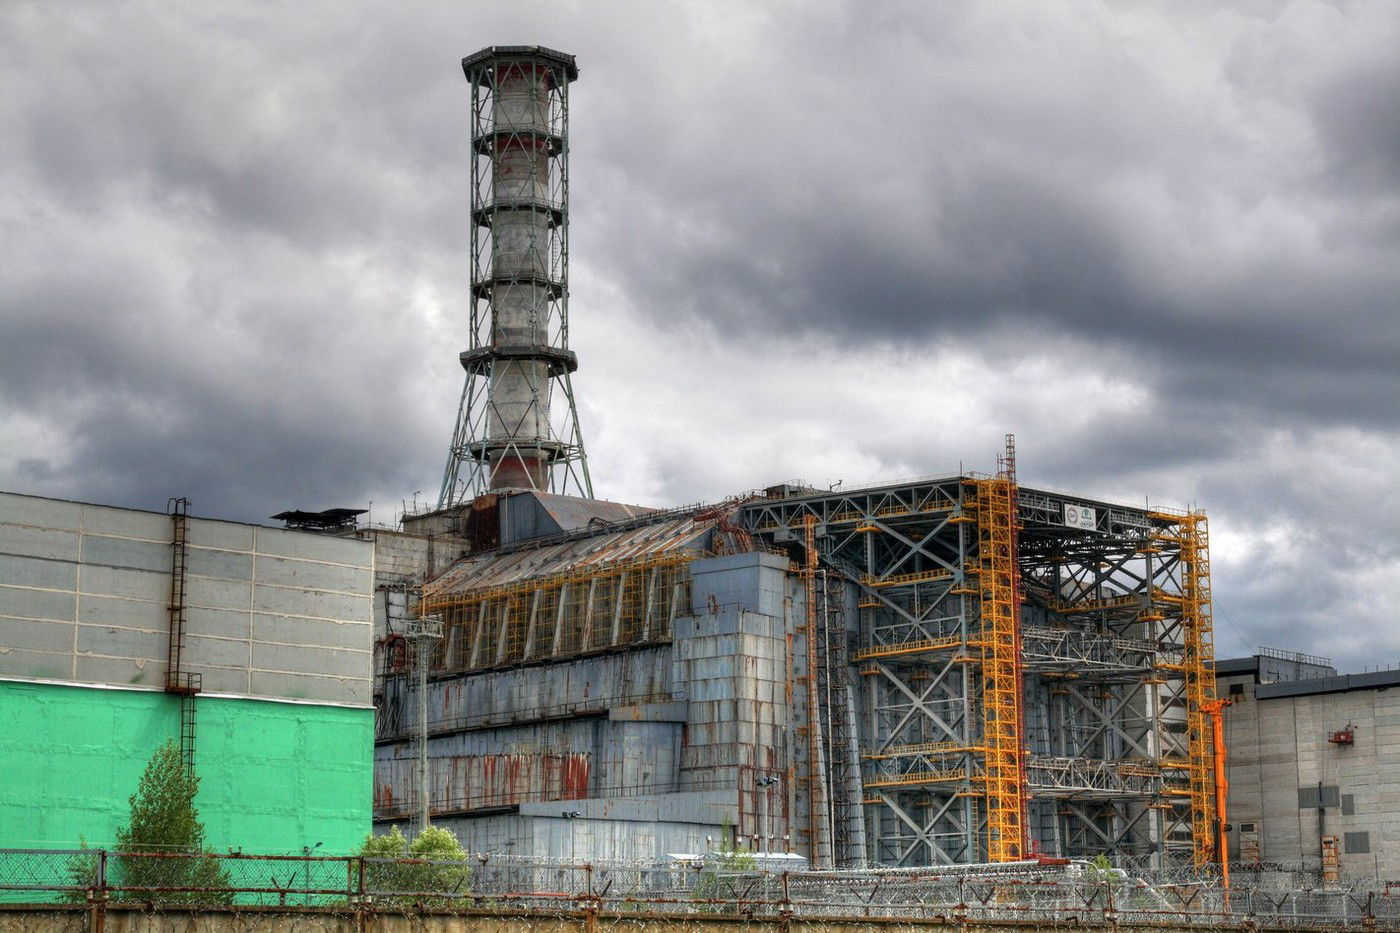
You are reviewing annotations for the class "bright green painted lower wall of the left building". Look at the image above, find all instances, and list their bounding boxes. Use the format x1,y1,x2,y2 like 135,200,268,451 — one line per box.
0,681,374,855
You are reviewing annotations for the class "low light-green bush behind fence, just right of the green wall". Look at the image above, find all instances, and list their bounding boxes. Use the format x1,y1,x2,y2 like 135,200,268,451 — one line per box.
360,827,472,904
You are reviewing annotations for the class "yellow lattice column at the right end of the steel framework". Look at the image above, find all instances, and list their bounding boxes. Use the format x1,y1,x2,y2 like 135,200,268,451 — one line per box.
1180,511,1219,869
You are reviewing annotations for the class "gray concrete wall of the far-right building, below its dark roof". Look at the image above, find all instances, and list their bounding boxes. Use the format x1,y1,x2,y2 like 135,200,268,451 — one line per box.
1219,675,1400,878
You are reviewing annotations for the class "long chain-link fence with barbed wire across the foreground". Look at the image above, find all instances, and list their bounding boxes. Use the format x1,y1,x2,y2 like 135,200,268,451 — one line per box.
0,849,1400,930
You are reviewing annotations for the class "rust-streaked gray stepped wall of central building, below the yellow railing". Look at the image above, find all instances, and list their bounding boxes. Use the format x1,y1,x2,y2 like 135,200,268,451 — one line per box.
375,553,792,859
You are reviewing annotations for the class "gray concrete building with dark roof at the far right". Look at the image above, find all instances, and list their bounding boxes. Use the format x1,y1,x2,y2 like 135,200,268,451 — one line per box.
1217,649,1400,878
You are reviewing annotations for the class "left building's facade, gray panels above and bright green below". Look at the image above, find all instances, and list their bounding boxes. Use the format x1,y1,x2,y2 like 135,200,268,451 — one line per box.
0,493,375,853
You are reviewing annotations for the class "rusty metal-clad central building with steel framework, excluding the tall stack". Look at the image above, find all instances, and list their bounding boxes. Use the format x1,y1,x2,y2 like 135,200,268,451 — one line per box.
375,475,1214,866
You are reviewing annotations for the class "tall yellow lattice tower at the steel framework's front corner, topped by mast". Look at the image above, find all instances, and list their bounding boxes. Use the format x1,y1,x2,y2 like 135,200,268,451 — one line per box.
974,436,1026,862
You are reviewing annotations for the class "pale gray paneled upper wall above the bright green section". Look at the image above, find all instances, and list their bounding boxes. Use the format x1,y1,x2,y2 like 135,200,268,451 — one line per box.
0,493,374,706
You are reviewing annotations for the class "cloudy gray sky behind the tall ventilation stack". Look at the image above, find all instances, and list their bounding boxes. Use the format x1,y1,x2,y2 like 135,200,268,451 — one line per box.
0,0,1400,670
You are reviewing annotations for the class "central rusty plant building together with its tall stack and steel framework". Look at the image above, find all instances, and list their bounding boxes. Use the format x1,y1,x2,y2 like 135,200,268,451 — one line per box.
375,46,1217,867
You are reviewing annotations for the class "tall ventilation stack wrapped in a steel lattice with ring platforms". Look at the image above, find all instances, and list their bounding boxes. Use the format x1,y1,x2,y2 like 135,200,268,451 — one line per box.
438,45,594,509
